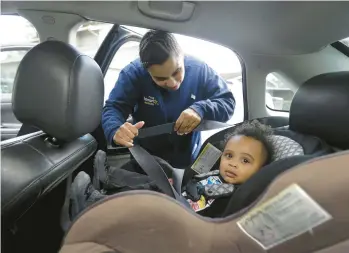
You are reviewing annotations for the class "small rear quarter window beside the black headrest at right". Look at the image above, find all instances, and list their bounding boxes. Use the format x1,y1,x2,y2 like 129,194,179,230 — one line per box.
265,72,295,112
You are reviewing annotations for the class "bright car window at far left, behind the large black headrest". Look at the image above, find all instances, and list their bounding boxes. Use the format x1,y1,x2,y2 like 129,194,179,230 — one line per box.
0,15,40,98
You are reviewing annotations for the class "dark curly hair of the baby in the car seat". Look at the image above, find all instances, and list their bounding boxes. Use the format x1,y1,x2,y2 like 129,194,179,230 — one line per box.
224,120,274,164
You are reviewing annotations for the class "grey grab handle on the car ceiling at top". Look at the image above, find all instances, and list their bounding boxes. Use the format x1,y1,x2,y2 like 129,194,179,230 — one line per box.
138,1,195,21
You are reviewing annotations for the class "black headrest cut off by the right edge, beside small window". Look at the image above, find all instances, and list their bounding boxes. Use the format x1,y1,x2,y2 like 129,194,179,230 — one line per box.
289,71,349,149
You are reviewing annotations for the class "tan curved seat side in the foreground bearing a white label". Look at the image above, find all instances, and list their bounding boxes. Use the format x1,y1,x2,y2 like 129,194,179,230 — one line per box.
60,151,349,253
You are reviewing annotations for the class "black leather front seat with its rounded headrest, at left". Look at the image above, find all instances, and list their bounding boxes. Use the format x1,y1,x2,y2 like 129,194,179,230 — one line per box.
1,41,104,249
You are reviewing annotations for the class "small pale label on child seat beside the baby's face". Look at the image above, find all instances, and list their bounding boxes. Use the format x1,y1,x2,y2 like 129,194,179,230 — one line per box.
191,143,222,174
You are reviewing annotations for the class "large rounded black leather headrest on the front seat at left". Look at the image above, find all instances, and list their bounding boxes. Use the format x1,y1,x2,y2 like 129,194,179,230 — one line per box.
12,41,104,141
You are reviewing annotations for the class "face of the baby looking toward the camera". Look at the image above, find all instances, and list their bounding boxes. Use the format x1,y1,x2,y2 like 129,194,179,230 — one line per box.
219,135,267,184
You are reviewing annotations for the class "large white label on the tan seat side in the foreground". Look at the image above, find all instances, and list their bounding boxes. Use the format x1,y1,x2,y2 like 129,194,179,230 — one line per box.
237,184,332,250
